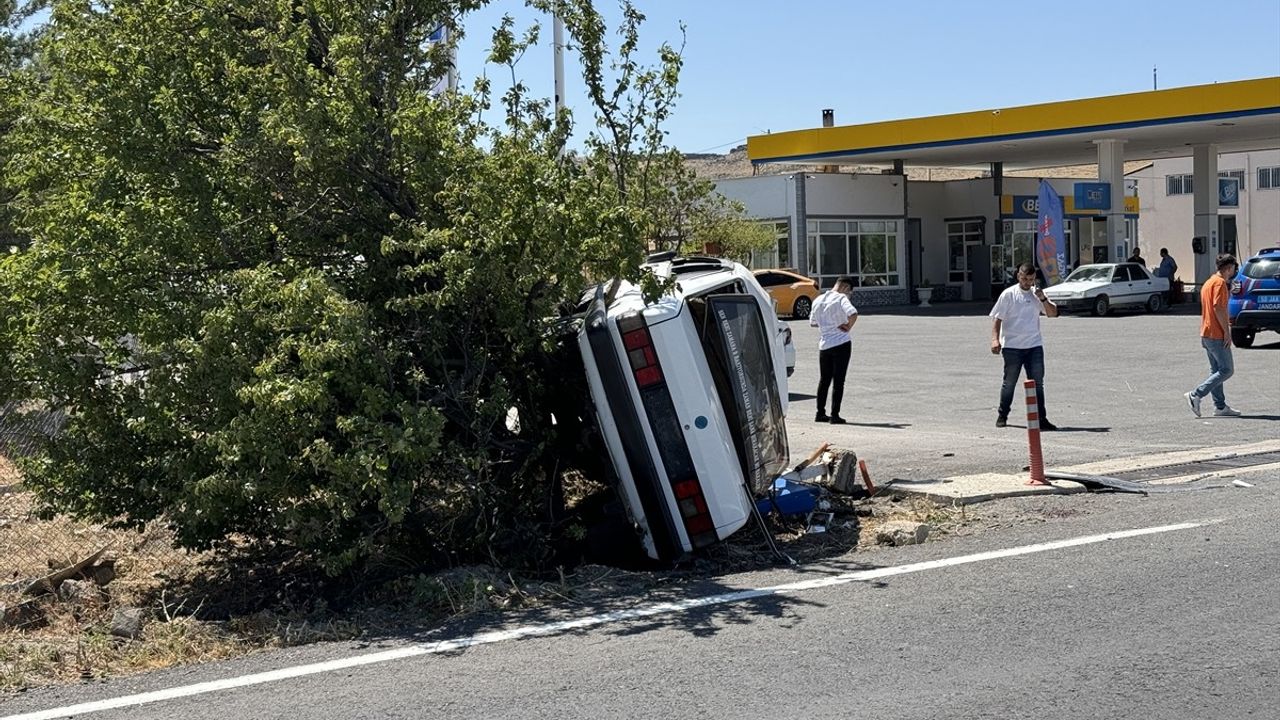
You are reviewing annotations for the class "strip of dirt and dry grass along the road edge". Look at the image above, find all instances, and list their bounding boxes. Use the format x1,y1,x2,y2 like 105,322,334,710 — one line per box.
0,459,1100,693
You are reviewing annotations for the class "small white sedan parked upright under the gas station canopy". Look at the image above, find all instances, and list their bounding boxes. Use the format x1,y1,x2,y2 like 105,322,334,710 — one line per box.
1044,263,1169,315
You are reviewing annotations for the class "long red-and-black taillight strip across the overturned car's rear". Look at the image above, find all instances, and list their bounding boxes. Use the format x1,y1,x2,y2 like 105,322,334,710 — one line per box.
618,313,719,547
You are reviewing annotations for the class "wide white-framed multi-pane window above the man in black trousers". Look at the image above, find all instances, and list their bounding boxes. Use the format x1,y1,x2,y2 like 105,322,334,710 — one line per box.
806,220,902,288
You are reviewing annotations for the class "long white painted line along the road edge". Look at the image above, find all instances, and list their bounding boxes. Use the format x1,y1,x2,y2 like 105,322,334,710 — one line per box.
0,521,1210,720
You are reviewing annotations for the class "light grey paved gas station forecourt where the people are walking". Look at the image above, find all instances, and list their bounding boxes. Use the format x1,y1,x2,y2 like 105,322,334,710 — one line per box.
787,304,1280,479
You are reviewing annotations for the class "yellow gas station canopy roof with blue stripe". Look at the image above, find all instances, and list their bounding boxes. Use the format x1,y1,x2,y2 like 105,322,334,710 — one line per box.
746,77,1280,170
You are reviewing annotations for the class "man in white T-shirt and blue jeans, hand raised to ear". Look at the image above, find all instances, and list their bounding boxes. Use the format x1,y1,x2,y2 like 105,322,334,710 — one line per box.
991,263,1057,430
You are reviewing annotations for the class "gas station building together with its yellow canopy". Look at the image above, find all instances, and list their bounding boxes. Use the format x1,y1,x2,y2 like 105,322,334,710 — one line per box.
716,77,1280,305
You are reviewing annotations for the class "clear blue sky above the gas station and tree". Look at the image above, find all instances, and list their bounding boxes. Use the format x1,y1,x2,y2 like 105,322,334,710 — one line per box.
458,0,1280,152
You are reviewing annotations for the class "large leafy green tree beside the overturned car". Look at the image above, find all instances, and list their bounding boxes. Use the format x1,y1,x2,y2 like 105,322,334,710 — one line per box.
0,0,721,571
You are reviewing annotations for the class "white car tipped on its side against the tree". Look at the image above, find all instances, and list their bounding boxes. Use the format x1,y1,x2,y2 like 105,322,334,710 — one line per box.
577,254,788,561
